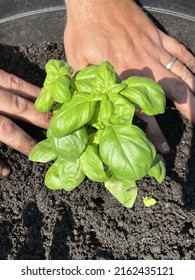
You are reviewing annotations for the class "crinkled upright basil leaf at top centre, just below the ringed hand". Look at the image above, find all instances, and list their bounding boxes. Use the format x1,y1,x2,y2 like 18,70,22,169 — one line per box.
95,61,117,87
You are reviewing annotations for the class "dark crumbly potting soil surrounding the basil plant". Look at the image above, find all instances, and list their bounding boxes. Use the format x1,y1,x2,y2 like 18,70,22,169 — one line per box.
0,22,195,260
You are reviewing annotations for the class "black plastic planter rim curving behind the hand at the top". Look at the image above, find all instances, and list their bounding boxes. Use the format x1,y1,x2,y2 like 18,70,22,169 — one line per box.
0,0,195,45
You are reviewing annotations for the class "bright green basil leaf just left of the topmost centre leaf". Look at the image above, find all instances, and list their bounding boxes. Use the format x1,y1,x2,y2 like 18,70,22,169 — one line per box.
75,65,98,93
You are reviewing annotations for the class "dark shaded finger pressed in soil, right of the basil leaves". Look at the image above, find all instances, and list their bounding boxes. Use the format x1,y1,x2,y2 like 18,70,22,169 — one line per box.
136,112,170,154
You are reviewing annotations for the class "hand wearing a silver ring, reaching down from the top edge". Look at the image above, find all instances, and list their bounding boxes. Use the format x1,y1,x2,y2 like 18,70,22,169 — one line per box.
64,0,195,153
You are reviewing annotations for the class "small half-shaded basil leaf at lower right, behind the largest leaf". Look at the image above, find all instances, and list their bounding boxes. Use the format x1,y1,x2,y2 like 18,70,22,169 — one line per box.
148,154,166,184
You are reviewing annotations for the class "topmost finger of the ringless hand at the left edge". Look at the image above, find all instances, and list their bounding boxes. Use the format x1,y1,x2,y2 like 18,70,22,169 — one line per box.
0,70,40,101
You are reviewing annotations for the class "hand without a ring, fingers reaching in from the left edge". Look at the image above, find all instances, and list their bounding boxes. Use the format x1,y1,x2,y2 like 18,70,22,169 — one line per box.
0,70,51,176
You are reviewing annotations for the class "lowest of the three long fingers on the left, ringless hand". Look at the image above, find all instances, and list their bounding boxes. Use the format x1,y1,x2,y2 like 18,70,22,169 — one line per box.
0,116,36,155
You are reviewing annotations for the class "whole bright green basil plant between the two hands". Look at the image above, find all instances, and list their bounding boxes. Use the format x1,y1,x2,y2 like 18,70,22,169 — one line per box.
29,60,165,208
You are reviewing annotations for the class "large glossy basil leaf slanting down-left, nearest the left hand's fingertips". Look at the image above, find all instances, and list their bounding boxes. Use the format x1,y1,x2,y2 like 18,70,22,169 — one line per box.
51,94,95,138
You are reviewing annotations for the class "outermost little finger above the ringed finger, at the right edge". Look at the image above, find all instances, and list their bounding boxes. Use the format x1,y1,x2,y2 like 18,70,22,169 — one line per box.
160,31,195,73
